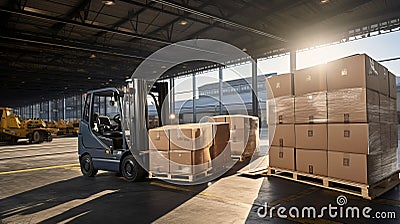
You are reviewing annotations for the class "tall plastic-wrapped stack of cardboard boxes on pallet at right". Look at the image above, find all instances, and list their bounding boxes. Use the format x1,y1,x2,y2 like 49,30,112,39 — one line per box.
267,54,400,199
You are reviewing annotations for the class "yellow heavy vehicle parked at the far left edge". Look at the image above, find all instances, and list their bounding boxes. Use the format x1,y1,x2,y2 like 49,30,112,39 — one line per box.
0,107,53,144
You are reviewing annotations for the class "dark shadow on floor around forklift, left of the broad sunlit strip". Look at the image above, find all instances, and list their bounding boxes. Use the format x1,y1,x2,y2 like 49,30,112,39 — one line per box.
0,158,250,223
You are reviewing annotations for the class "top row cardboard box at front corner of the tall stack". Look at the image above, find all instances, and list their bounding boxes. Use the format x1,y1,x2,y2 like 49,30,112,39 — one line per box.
326,54,381,92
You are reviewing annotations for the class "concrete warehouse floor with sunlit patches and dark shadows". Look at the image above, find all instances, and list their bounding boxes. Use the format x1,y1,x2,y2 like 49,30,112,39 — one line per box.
0,138,400,223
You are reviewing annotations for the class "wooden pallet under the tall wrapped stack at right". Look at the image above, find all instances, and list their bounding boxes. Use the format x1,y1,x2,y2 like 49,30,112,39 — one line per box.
267,167,400,200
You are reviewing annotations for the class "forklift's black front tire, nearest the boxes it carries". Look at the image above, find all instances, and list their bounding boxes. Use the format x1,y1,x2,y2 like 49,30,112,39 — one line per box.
121,155,145,182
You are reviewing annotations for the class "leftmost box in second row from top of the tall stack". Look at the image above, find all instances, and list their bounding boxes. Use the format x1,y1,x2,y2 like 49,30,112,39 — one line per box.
267,96,294,125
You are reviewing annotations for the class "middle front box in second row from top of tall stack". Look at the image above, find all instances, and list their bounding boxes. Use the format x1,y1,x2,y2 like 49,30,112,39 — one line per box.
294,91,328,124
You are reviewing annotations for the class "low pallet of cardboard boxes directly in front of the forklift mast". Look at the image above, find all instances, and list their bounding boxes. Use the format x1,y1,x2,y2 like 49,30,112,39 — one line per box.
149,123,230,182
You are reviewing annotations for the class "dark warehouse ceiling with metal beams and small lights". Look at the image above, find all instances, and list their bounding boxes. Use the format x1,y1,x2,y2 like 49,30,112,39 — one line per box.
0,0,400,106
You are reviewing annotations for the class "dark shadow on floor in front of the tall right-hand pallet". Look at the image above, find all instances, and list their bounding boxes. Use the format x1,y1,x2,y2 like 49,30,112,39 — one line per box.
246,177,400,223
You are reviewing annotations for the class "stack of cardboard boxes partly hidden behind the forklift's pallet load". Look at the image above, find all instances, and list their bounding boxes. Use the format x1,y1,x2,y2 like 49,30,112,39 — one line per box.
210,115,259,158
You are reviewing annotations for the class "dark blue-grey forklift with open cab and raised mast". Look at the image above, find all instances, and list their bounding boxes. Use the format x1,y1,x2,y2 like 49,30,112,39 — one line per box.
78,79,169,182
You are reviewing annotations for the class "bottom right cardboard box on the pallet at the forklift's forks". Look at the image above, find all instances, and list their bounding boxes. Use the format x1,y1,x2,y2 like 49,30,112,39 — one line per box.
169,148,211,175
